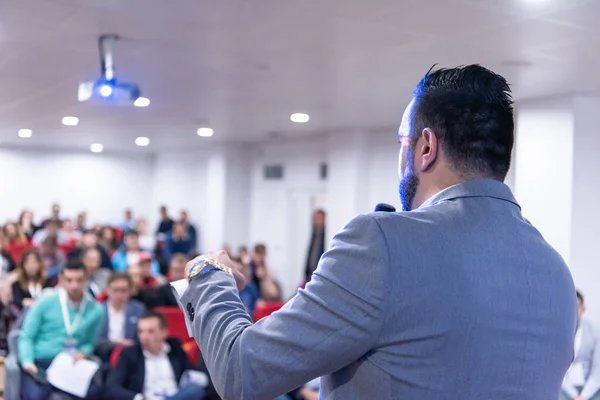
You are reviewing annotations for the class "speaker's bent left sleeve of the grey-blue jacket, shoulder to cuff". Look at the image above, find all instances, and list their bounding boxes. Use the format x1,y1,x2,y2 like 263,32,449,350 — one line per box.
182,215,389,400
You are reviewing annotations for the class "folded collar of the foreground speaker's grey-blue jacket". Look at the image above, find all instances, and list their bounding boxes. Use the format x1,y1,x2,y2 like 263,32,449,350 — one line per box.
418,179,521,210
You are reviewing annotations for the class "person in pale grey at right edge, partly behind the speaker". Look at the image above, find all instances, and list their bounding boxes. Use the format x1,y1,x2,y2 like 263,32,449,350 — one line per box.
560,292,600,400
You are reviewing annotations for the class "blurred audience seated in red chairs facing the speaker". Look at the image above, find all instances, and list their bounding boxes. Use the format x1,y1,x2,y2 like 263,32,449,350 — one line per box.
0,204,322,400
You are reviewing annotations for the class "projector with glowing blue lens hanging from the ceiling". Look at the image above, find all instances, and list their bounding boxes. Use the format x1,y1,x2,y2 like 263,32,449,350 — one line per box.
77,35,145,107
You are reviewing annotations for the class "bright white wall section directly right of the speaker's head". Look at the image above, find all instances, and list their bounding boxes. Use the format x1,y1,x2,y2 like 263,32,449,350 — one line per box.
514,99,574,263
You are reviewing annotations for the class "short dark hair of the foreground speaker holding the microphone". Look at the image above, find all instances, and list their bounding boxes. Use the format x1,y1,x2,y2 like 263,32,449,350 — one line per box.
410,65,514,180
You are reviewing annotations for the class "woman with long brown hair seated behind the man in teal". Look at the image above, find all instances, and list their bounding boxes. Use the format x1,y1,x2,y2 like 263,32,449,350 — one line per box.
12,249,52,311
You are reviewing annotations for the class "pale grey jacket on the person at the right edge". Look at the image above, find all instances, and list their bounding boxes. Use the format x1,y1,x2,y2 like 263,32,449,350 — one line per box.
562,320,600,399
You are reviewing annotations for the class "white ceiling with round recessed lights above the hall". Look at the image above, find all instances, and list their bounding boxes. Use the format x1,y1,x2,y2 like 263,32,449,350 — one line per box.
0,0,600,152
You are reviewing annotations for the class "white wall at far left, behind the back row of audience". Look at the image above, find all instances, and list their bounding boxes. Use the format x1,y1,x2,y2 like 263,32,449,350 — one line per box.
0,149,153,227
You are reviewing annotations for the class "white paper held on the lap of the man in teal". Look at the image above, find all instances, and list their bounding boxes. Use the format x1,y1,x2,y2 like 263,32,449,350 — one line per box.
46,352,99,398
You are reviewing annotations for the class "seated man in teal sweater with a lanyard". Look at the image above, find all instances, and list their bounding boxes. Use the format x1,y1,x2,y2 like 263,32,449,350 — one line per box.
18,262,104,400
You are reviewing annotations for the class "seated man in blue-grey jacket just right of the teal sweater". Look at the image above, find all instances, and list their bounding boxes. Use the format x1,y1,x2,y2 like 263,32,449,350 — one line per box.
96,272,146,361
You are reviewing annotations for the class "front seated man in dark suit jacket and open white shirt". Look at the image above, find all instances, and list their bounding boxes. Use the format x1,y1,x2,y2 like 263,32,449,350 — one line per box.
104,312,206,400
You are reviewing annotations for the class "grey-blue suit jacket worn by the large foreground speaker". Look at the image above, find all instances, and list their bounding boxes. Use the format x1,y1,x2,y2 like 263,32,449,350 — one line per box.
181,180,577,400
